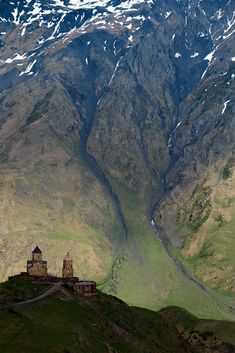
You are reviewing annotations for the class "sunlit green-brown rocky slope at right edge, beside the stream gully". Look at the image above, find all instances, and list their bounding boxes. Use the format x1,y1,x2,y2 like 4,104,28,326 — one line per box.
159,161,235,302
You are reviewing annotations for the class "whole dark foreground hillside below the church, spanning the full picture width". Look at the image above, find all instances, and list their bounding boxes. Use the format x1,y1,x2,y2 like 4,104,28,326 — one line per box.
0,278,235,353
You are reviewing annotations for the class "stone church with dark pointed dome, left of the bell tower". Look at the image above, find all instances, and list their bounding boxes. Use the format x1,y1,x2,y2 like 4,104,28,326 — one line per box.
27,246,47,277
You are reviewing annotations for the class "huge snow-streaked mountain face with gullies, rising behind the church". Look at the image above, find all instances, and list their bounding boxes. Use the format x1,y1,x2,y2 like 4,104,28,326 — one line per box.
0,0,235,317
